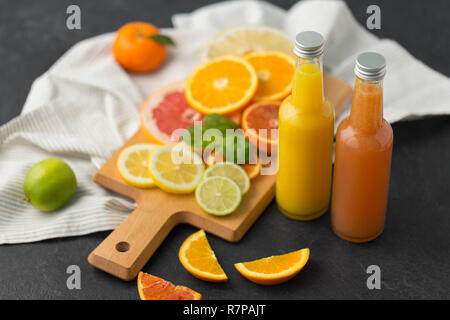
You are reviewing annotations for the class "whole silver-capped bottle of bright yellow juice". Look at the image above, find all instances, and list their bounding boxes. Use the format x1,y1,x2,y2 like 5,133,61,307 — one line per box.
276,31,334,220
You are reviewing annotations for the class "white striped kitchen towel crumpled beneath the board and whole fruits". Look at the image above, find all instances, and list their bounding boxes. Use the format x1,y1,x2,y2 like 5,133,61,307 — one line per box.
0,0,450,244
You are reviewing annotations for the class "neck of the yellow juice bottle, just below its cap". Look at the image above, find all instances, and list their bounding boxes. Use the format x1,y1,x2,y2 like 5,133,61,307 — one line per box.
292,57,324,111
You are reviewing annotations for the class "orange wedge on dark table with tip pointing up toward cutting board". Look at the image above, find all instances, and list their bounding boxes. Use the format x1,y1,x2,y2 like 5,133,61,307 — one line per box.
178,229,228,282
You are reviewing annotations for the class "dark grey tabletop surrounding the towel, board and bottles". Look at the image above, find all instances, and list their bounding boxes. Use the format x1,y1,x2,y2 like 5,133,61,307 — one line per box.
0,0,450,299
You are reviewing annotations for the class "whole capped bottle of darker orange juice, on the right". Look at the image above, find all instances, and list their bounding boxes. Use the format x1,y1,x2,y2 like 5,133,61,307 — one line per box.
331,52,393,242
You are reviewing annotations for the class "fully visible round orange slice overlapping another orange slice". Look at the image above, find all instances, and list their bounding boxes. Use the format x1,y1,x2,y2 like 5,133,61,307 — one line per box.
185,56,258,114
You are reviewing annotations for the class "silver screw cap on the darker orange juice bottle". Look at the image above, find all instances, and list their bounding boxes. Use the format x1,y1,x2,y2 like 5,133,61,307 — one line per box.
355,52,386,81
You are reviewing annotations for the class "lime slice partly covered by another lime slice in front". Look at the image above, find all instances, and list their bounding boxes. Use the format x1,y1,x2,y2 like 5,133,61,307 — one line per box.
204,162,250,195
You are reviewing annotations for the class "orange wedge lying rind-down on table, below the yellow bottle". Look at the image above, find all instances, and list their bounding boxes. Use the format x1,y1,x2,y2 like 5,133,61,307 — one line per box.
234,248,309,285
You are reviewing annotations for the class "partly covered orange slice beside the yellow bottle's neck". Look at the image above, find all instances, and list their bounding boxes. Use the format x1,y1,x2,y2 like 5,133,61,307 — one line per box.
244,51,295,101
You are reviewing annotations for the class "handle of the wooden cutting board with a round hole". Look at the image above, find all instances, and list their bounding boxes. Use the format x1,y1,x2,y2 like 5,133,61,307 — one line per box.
88,206,177,281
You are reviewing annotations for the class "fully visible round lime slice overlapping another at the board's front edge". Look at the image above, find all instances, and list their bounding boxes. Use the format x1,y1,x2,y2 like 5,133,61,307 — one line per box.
195,176,242,216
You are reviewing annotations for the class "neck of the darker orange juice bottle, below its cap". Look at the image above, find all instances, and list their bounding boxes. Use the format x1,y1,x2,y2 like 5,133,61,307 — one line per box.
350,77,383,131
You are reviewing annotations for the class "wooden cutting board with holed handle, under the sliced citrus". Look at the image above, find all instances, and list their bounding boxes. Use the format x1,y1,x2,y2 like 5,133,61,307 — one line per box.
88,76,352,280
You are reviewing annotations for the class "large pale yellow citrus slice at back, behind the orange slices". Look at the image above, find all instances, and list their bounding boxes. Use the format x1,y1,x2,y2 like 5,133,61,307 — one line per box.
200,25,293,62
